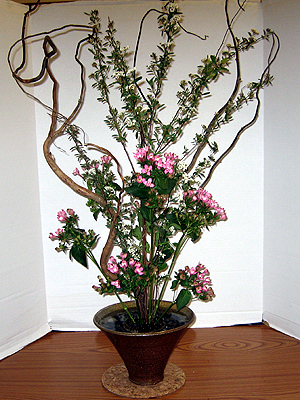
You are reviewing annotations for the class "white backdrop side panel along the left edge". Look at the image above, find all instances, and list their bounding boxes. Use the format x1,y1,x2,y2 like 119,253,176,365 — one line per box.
0,0,50,359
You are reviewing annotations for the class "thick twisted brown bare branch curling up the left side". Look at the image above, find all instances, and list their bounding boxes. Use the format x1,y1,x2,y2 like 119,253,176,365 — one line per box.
8,5,119,279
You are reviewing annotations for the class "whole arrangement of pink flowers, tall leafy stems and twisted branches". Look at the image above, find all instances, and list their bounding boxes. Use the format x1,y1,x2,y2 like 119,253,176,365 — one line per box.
11,0,279,331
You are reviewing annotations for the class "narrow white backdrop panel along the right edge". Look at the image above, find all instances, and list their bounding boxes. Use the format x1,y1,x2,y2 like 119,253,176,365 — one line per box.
264,0,300,338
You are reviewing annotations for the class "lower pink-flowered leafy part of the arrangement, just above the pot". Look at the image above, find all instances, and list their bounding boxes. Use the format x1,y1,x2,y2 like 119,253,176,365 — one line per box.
50,146,227,330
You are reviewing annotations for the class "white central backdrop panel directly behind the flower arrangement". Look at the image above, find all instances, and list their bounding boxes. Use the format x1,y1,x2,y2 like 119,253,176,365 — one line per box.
28,0,264,330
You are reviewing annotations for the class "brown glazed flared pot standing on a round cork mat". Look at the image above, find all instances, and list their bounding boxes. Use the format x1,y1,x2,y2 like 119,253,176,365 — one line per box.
94,301,195,385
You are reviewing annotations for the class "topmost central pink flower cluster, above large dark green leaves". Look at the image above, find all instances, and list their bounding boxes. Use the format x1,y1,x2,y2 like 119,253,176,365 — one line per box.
134,146,178,187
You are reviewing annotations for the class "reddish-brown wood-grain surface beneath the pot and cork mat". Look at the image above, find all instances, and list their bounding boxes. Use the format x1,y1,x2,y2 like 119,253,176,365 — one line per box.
0,325,300,400
